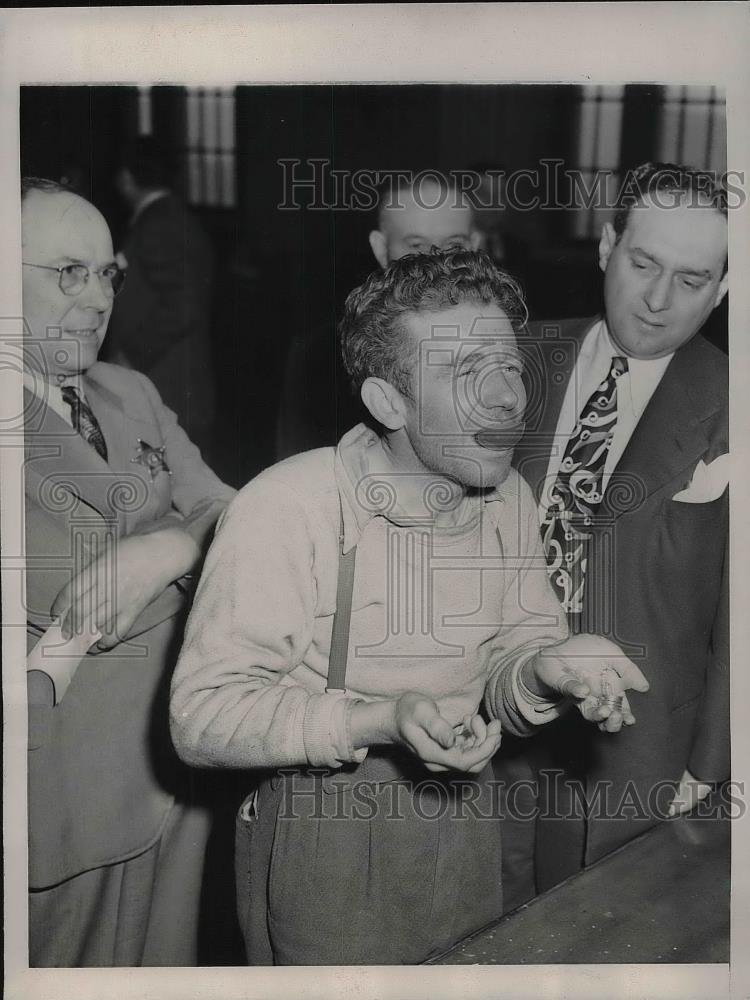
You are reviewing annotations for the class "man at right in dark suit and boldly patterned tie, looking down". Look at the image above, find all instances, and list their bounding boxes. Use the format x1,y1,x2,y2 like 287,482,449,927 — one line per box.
506,164,729,894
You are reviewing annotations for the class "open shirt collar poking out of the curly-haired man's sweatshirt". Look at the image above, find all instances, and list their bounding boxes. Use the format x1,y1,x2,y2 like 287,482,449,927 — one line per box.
334,424,518,552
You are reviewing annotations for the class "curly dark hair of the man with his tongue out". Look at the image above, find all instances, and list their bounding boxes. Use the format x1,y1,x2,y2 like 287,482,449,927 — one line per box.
339,247,528,398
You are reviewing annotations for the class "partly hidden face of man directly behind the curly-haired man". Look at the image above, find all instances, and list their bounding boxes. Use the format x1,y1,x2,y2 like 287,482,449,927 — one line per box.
370,183,478,267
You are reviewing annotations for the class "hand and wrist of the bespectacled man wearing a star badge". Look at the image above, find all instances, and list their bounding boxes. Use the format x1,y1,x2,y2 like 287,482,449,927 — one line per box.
51,528,199,649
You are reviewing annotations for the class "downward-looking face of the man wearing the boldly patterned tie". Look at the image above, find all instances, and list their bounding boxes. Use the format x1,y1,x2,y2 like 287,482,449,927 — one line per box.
600,194,727,359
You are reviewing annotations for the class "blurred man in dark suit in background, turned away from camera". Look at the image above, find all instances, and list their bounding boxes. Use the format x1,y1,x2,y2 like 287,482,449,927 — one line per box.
107,136,215,449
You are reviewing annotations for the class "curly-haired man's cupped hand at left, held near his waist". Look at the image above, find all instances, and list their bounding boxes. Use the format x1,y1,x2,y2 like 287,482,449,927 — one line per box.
391,692,501,774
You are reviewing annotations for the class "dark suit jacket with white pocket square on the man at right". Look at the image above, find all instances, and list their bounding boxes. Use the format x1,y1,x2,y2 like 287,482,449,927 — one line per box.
515,319,729,876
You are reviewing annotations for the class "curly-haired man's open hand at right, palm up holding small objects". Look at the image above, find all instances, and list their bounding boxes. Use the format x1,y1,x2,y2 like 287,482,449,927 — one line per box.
523,635,649,733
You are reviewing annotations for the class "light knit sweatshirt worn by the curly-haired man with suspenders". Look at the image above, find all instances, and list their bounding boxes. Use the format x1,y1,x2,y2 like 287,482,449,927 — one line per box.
171,425,567,768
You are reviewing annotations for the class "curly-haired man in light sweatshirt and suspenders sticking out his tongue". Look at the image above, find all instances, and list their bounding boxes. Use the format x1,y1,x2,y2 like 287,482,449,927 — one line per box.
171,249,647,965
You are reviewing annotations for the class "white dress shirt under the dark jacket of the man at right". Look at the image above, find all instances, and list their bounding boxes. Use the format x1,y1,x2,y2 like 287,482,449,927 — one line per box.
539,320,672,519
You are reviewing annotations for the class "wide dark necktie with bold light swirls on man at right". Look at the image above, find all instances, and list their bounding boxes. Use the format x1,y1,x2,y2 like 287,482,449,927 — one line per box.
542,357,628,615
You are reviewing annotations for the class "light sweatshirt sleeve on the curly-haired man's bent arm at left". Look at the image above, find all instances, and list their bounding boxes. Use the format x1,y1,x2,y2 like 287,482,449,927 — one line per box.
171,481,364,768
